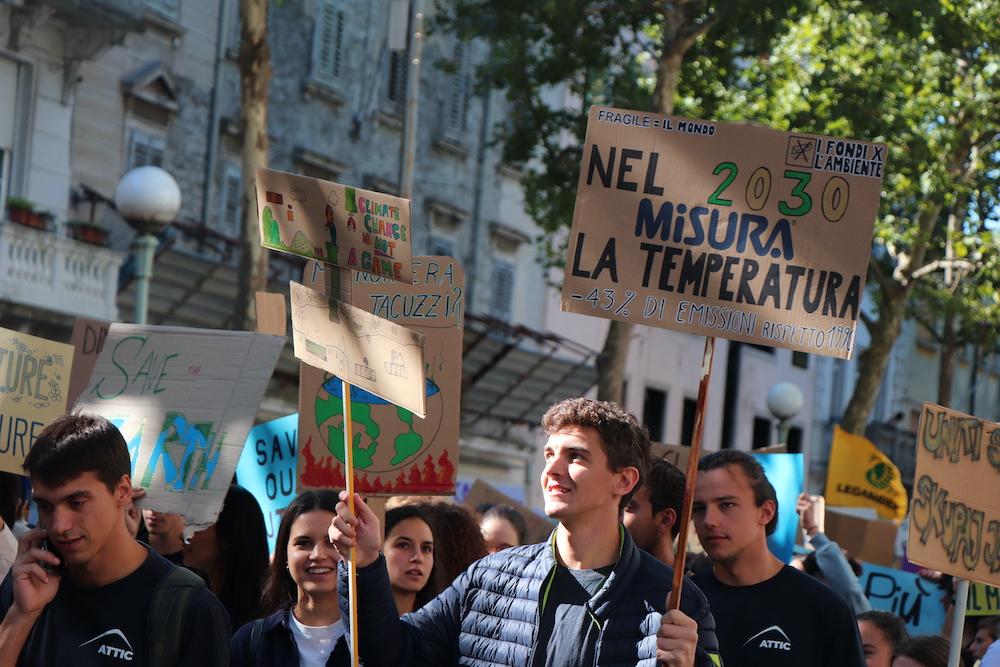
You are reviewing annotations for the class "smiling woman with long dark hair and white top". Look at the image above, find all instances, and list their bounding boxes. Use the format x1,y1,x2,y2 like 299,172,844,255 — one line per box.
230,489,351,667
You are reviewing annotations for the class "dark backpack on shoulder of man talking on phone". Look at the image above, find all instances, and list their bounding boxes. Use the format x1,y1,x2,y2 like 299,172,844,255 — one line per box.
146,567,205,667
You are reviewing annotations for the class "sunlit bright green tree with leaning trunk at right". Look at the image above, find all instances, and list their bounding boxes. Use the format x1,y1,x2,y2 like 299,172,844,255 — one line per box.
704,0,1000,433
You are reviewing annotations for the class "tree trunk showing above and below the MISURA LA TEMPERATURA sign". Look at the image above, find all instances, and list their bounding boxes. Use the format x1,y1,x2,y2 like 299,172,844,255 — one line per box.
597,2,692,403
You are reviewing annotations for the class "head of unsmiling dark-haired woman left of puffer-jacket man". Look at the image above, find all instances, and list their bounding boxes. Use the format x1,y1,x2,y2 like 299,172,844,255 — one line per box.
382,505,437,616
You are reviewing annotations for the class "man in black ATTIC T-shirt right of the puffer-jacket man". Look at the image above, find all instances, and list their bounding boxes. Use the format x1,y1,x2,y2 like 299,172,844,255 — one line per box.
692,449,865,667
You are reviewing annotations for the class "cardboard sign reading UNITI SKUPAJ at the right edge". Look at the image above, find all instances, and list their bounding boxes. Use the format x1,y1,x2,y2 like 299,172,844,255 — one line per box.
906,403,1000,586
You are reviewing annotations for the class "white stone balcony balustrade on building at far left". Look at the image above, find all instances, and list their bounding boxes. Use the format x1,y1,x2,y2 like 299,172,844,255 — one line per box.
0,222,124,321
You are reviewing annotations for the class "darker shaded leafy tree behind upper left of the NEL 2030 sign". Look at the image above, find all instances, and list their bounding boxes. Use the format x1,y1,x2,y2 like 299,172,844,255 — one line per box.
437,0,804,401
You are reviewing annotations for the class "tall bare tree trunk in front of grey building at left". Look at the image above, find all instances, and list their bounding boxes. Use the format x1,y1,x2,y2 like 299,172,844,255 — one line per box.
233,0,271,330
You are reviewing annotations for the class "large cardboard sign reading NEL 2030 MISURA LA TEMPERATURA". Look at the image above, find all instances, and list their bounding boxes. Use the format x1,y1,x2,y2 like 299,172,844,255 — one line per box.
562,106,885,358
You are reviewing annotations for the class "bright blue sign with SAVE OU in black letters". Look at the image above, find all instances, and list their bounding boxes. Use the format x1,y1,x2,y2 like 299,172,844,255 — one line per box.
236,414,299,554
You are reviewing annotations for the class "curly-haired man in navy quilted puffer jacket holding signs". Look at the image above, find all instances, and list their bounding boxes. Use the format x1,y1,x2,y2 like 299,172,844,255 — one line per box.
330,398,720,667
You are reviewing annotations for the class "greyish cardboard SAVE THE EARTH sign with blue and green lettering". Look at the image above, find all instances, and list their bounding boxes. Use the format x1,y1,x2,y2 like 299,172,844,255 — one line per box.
78,324,285,526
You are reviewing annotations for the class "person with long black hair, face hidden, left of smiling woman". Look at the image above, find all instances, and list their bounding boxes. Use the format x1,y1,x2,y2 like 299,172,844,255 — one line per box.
183,484,268,628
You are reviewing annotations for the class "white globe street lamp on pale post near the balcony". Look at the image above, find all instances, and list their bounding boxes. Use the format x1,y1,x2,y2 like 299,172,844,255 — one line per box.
115,166,181,324
